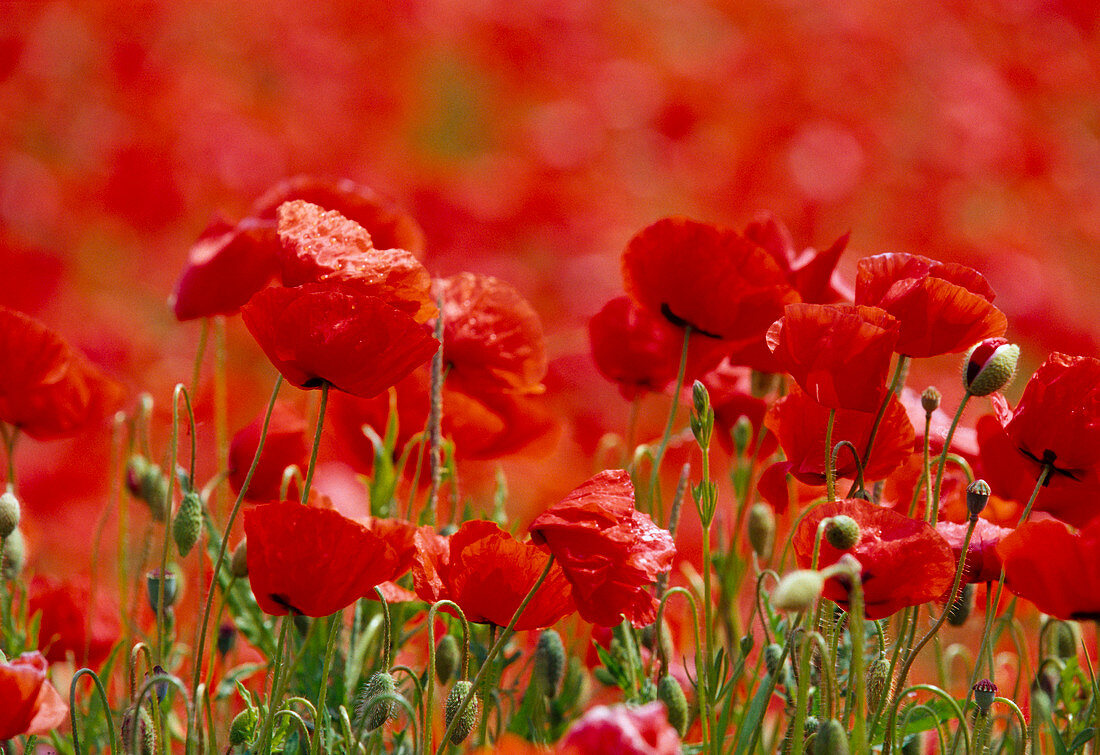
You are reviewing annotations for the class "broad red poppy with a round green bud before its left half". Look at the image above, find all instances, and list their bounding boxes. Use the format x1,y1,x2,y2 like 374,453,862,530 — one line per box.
793,499,956,619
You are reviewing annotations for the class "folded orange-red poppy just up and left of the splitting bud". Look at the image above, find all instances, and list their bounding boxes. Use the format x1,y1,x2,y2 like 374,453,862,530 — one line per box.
856,254,1008,357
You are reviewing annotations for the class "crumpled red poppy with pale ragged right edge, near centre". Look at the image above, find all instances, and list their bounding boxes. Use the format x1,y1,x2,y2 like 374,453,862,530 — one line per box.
530,469,677,626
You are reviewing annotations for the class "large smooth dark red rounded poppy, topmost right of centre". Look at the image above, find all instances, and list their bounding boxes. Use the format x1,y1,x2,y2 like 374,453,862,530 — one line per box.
623,218,799,341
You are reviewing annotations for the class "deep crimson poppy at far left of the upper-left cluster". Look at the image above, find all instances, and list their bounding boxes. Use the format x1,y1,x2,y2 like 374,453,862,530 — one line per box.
169,218,278,320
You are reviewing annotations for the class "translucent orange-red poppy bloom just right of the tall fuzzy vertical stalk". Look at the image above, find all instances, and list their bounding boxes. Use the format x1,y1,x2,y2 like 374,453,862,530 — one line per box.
435,273,547,396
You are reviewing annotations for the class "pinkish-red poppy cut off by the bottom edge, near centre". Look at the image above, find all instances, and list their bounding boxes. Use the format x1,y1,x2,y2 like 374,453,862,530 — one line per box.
558,702,681,755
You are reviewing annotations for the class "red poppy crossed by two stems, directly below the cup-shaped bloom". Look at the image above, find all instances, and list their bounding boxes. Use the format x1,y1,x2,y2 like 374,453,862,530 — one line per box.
763,386,914,485
